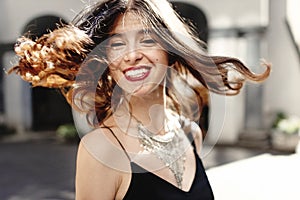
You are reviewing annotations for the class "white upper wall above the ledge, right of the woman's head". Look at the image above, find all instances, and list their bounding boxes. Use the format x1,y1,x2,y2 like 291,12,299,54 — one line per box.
173,0,269,29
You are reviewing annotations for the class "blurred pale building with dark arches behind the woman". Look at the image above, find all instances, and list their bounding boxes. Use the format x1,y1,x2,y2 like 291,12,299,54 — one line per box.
0,0,300,146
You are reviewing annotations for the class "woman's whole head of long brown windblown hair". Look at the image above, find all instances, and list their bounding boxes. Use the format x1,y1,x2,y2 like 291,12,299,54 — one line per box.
10,0,270,126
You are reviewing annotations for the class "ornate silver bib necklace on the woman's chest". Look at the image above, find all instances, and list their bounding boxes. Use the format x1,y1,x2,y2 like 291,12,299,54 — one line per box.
137,117,186,189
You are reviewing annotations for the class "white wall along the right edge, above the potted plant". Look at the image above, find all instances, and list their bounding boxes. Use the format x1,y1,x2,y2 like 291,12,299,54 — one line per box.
264,0,300,116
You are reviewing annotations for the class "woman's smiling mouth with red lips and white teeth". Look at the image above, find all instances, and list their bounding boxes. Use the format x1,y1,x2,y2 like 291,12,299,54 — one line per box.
123,66,151,81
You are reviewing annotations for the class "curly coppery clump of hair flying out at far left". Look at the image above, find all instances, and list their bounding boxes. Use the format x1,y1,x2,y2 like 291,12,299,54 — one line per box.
10,26,92,88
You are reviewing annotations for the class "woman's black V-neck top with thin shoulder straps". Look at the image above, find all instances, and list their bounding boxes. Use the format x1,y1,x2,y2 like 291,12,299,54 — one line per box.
106,127,214,200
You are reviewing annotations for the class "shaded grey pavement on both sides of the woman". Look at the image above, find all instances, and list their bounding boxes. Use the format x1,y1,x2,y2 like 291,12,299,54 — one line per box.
0,132,278,200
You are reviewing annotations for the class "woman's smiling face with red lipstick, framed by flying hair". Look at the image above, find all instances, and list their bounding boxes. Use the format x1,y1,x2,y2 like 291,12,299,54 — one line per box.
106,12,168,96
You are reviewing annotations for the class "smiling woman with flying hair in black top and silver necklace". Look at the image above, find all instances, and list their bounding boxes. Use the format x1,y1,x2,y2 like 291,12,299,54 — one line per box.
11,0,270,200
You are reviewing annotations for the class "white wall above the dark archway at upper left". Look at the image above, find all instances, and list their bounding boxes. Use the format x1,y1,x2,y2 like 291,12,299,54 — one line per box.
0,0,89,42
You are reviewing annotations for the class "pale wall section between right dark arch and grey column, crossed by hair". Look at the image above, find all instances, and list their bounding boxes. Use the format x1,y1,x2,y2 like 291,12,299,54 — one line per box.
208,35,247,143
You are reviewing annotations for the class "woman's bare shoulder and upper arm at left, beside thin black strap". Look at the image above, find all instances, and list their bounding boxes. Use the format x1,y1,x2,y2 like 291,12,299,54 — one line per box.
76,128,130,200
